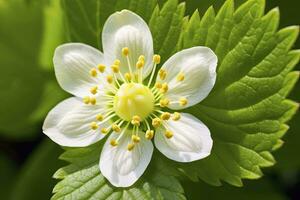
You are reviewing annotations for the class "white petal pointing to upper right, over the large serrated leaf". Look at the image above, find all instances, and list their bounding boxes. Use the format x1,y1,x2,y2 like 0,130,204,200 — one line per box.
157,46,218,110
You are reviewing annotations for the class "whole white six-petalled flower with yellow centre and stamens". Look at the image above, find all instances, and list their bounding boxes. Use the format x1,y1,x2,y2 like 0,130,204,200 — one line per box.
43,10,217,187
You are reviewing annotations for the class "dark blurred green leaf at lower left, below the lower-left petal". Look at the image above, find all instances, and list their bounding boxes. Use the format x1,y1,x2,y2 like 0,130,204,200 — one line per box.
10,140,62,200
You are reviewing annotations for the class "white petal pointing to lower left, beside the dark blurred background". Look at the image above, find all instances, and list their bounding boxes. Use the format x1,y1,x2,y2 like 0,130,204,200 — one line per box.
43,97,108,147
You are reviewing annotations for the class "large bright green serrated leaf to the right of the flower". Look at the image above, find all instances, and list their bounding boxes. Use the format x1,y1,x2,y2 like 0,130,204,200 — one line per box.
165,0,300,186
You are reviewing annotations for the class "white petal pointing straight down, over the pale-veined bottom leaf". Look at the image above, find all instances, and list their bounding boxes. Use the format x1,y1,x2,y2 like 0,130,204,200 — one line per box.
99,131,153,187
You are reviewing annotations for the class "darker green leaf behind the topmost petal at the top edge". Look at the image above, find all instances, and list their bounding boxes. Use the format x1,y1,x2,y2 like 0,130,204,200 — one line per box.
63,0,156,49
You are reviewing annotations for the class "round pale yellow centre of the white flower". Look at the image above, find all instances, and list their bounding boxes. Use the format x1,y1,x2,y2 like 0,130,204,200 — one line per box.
113,83,155,121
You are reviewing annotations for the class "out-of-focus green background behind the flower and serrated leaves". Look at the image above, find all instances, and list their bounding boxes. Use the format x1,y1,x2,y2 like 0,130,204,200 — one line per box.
0,0,300,200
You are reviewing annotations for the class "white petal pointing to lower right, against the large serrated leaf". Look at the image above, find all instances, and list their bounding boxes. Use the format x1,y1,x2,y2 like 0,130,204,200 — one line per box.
154,113,213,162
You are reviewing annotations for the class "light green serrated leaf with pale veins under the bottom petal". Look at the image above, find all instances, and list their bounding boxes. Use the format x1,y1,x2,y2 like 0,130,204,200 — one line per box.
52,143,185,200
